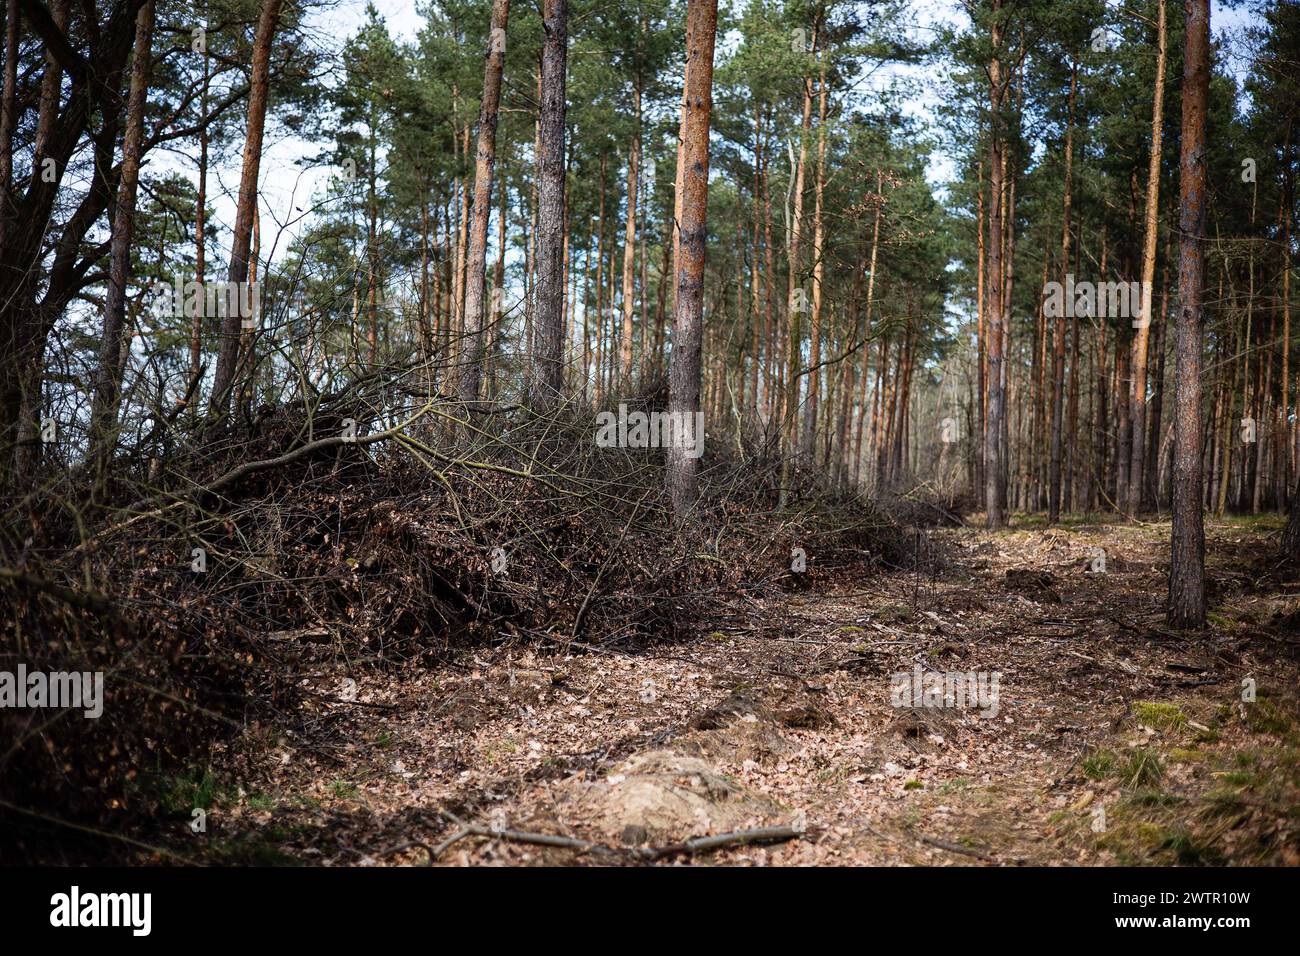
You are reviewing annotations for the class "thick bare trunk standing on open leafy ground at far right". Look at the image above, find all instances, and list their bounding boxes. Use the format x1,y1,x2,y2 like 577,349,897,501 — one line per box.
1169,0,1210,627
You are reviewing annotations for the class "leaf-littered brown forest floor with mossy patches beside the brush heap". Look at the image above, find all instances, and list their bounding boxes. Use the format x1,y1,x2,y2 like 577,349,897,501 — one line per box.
168,516,1300,865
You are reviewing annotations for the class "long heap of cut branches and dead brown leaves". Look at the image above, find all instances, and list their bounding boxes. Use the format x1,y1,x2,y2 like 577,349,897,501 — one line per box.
0,377,915,863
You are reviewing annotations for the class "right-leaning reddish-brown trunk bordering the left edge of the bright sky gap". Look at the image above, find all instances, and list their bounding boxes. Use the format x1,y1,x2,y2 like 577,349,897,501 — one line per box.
208,0,283,416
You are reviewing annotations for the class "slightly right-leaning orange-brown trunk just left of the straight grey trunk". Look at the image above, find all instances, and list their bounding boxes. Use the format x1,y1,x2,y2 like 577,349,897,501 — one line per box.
459,0,510,402
